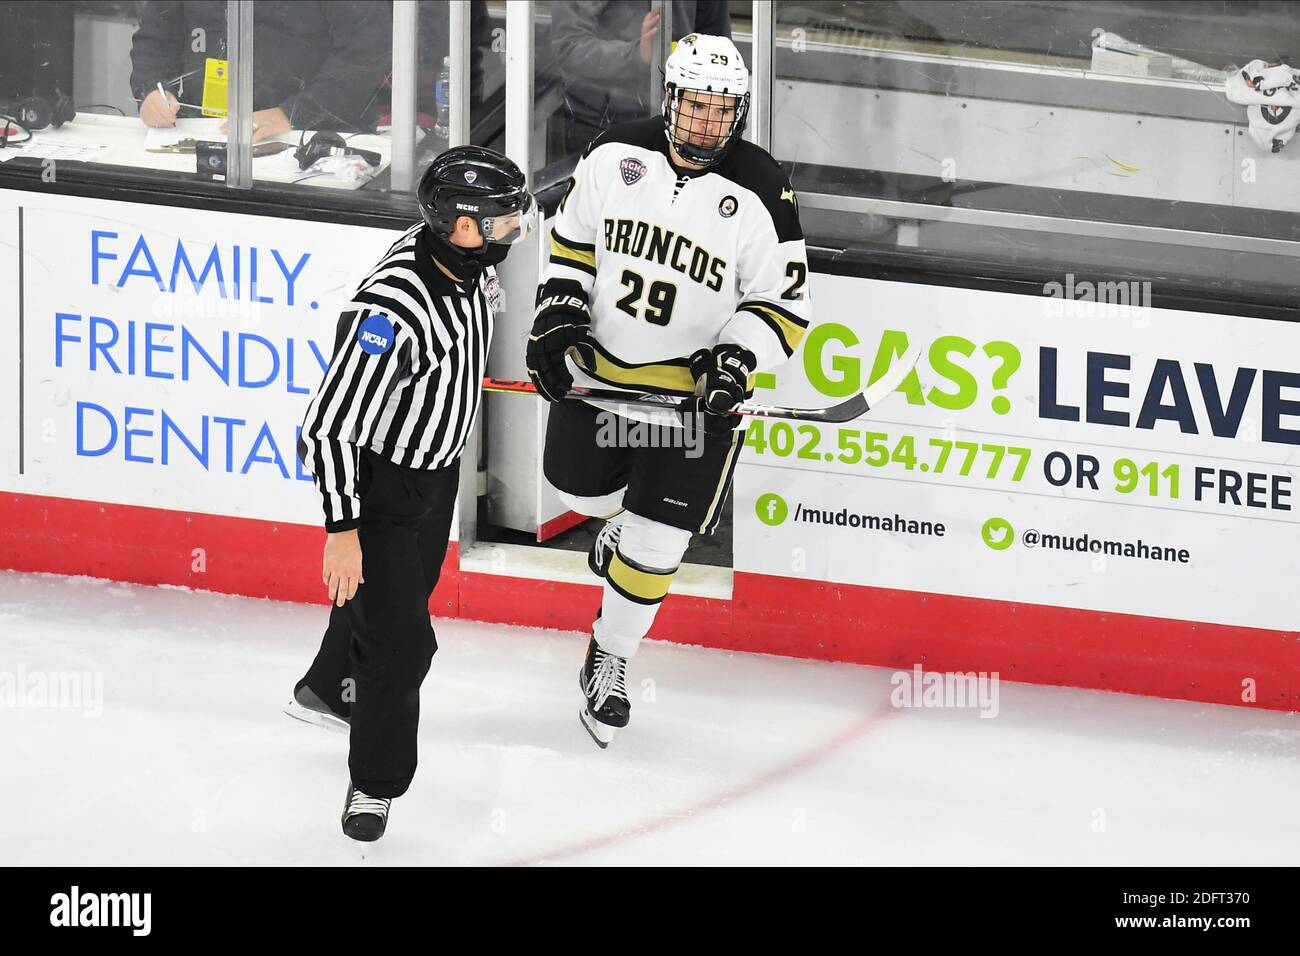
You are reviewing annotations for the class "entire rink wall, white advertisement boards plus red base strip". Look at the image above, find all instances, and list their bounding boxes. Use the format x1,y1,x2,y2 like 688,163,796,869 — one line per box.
0,190,1300,709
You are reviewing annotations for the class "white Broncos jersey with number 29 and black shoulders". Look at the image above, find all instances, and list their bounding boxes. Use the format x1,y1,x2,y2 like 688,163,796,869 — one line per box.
538,118,810,395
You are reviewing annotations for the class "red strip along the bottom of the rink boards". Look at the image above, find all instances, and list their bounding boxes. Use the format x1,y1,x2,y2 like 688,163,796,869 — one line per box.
0,492,1300,710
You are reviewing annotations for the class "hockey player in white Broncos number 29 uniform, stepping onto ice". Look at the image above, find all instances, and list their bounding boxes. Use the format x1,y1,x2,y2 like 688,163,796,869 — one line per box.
527,34,809,748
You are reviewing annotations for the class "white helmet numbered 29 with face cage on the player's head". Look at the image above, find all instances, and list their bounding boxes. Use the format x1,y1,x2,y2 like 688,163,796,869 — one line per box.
663,34,749,165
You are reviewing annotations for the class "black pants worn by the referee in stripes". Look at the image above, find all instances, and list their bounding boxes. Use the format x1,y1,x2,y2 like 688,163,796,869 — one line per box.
297,449,460,797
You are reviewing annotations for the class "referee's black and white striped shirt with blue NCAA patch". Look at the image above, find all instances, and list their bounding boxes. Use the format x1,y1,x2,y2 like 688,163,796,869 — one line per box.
299,224,499,532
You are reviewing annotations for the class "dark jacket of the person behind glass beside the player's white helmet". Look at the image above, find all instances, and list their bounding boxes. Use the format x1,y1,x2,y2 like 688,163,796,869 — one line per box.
551,0,731,127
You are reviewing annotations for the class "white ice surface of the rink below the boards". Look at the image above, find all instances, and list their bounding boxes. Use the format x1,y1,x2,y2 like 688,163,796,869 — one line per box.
0,572,1300,865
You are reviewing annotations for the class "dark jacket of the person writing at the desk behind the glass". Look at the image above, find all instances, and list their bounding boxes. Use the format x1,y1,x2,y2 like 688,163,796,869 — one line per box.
131,0,393,130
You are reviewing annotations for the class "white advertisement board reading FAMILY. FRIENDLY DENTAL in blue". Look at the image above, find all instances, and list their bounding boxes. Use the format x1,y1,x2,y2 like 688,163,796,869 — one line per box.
0,191,400,525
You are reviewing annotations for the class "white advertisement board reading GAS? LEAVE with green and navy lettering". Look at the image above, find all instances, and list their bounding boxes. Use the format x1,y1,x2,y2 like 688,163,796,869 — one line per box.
735,274,1300,630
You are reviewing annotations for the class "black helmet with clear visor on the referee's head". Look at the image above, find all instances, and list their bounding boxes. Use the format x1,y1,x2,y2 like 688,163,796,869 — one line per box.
416,146,537,245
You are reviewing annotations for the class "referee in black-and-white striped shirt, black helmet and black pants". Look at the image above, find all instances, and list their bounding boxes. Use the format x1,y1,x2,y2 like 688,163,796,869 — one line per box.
287,146,537,840
